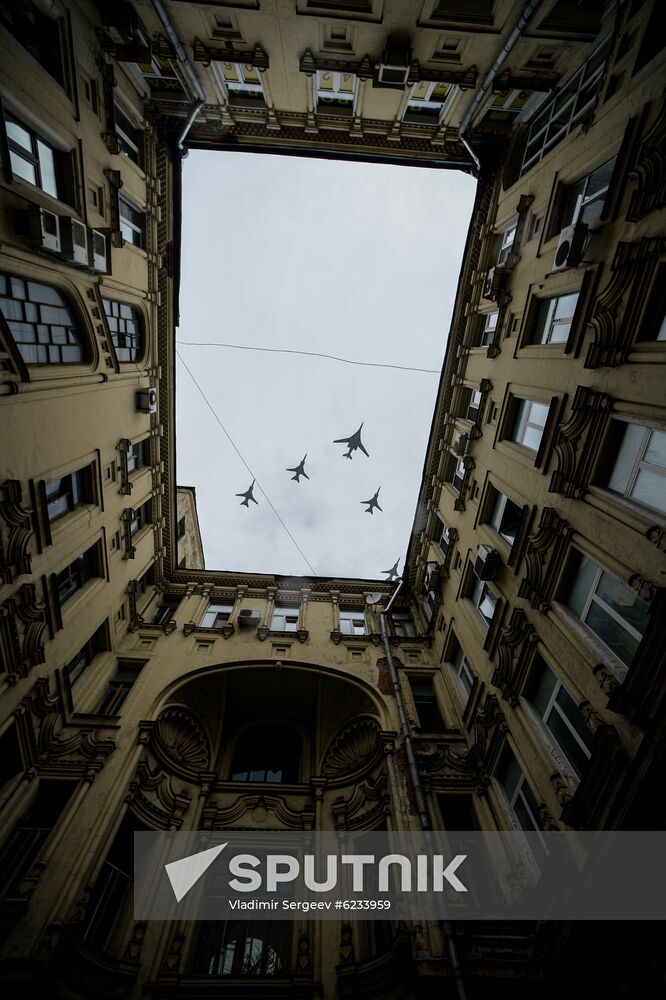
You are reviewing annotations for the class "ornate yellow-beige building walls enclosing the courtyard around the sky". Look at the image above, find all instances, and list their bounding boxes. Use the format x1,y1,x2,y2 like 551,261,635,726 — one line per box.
0,0,666,1000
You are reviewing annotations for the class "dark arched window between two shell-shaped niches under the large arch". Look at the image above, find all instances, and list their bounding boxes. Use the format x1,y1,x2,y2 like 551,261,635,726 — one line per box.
231,726,301,785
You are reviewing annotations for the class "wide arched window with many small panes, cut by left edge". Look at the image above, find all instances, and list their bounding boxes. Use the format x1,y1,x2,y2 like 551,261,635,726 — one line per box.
0,274,85,365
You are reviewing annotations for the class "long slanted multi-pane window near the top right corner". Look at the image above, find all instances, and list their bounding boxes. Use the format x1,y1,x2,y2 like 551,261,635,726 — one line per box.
520,37,610,176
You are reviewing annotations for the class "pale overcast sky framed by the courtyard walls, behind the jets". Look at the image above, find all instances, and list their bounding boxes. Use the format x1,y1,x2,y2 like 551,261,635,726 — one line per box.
176,150,476,579
